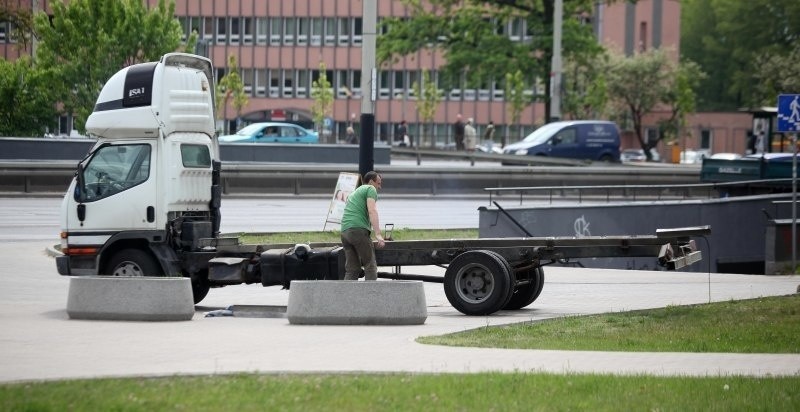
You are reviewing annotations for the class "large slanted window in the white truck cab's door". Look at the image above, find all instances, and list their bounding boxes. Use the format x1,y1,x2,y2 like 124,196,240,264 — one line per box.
82,144,150,202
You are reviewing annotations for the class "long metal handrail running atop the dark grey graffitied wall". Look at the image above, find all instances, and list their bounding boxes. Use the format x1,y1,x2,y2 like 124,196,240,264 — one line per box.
483,179,792,205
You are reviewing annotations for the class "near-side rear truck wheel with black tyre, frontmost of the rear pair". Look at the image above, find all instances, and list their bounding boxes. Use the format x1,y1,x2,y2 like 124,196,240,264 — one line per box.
444,250,512,316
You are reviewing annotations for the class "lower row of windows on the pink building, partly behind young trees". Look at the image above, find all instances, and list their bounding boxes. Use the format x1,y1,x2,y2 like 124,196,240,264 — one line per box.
222,68,544,101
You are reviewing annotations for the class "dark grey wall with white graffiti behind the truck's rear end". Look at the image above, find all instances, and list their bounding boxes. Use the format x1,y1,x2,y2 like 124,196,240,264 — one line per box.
479,194,791,274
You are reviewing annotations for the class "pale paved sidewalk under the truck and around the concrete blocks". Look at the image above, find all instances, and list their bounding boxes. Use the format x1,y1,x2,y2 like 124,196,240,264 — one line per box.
0,242,800,382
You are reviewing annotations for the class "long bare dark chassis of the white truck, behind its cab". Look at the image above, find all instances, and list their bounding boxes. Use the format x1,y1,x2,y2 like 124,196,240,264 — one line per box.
198,226,710,316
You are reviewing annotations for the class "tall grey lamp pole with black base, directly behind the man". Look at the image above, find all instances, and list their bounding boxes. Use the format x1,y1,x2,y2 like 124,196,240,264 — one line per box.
358,0,378,177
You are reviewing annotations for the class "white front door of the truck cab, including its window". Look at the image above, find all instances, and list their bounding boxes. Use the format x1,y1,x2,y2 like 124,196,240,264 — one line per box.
67,141,158,232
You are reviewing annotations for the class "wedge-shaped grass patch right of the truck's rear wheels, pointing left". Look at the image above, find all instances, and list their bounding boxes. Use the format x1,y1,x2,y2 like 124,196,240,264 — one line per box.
417,294,800,353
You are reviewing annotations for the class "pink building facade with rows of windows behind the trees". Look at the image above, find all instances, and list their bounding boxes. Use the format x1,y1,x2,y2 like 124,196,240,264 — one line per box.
0,0,747,155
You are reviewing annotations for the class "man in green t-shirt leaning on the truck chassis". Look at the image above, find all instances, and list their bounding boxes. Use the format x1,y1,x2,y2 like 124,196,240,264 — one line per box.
341,171,386,280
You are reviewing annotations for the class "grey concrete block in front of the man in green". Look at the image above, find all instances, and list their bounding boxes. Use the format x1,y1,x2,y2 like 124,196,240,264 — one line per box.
286,280,428,325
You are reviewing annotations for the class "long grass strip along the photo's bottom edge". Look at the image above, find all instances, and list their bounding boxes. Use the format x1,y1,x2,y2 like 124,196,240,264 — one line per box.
0,373,800,412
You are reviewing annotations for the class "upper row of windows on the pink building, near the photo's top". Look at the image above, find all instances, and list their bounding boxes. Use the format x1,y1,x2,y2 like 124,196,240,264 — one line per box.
178,16,532,46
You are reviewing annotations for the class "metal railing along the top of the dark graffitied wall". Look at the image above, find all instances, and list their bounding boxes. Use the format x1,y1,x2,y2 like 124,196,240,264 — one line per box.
484,179,792,205
